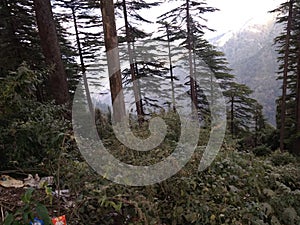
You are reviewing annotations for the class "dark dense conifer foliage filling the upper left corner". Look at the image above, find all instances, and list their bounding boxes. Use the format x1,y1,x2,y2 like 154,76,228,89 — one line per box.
0,0,43,77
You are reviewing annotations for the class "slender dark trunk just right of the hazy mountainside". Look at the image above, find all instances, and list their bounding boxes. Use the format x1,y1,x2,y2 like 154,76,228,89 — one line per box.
280,0,294,152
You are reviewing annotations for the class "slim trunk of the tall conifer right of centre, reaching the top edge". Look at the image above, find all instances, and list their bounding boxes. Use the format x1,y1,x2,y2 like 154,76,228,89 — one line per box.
186,0,198,110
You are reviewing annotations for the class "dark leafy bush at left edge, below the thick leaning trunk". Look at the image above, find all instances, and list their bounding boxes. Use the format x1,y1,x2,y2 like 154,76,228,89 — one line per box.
0,63,70,169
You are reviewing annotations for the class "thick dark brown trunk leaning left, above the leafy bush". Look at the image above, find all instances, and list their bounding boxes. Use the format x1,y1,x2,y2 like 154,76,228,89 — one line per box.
33,0,70,104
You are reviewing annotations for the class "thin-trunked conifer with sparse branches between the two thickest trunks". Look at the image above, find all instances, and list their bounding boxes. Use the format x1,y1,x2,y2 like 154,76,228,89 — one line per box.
55,0,103,116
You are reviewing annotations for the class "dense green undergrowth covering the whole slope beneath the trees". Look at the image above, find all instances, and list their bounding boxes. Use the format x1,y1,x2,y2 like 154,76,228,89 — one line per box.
0,65,300,225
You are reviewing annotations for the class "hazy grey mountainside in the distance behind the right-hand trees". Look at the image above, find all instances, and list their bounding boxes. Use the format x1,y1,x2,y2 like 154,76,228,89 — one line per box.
210,15,280,125
